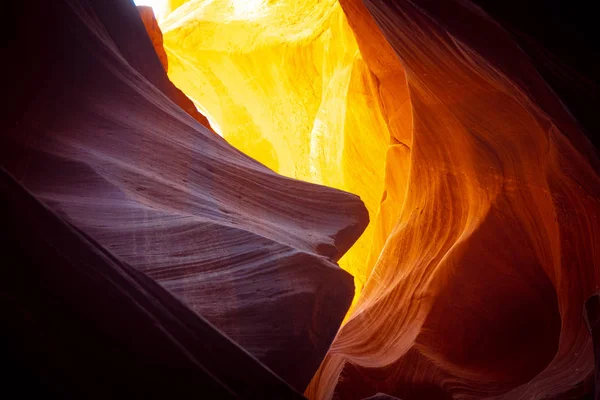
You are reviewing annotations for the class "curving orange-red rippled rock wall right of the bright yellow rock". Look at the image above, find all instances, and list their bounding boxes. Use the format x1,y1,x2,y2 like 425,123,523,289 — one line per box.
307,0,600,399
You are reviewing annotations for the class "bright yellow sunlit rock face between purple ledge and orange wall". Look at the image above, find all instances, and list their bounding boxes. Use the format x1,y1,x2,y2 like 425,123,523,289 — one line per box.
161,0,390,300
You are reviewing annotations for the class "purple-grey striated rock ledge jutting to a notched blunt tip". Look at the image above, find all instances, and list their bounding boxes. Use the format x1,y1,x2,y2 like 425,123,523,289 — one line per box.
0,0,368,390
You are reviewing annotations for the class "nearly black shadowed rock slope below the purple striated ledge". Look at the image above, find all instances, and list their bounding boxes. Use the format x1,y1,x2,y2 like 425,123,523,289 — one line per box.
0,169,304,399
